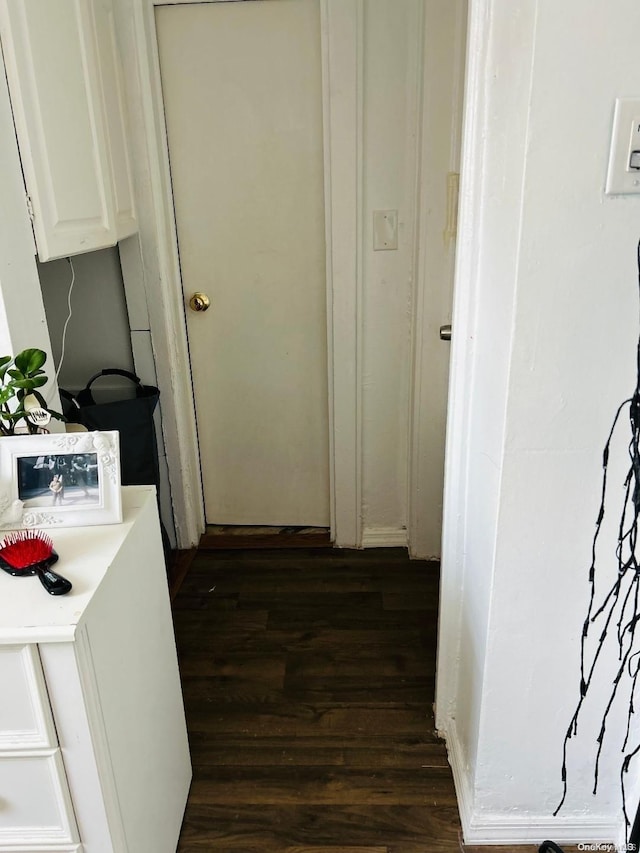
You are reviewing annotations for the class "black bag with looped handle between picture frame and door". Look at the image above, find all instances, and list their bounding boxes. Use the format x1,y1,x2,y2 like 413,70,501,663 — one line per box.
60,367,160,487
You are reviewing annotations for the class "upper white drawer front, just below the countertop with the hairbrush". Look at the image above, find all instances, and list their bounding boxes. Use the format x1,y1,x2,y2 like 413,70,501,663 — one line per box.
0,645,58,752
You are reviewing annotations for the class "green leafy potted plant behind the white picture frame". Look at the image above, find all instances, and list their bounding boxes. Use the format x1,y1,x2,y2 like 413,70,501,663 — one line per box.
0,349,65,436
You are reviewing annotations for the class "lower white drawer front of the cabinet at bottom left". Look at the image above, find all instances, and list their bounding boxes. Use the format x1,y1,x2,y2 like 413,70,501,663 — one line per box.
0,749,79,850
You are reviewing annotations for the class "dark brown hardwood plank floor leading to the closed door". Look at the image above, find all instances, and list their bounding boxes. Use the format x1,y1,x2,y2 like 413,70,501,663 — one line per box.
174,549,552,853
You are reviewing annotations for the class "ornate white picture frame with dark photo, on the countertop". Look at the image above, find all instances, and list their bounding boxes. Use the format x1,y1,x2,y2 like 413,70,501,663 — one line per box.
0,431,122,530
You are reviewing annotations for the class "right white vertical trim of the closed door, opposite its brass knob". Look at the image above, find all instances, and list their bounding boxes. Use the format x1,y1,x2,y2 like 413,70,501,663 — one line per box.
320,0,363,548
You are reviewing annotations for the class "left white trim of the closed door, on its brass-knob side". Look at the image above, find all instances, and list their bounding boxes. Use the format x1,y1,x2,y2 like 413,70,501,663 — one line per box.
115,0,204,548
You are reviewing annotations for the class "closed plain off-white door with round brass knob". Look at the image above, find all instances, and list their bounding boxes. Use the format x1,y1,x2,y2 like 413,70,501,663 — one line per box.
156,0,329,526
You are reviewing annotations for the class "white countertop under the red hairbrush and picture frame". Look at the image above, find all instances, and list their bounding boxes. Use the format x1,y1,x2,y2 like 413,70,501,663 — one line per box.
0,486,155,645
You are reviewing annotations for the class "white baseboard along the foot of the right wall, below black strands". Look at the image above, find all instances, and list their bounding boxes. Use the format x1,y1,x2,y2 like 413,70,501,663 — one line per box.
442,720,621,849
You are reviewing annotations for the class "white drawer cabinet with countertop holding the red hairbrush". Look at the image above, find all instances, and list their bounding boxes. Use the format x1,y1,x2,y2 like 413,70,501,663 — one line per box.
0,487,191,853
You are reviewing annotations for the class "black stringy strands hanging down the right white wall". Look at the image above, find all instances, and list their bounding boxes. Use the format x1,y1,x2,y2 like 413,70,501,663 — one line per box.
554,238,640,840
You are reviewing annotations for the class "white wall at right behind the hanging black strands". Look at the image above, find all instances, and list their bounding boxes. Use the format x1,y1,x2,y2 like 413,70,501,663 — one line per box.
438,0,640,843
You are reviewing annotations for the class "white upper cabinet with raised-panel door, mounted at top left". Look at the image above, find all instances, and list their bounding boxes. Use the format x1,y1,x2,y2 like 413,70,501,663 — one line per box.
0,0,137,261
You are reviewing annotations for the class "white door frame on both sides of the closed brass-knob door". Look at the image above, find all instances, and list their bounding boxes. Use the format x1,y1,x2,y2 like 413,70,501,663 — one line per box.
116,0,364,548
